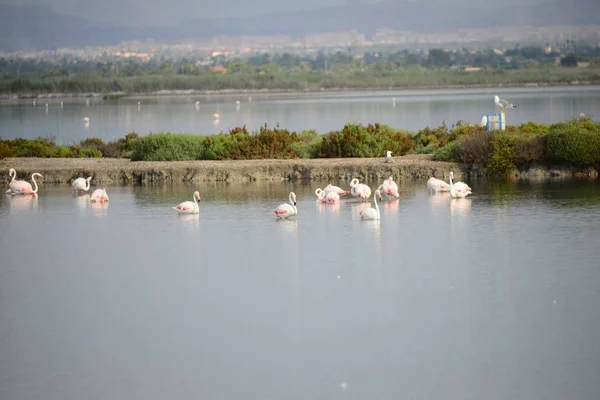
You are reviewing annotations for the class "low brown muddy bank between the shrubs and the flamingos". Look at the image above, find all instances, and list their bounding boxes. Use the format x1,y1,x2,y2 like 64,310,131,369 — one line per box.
0,155,598,184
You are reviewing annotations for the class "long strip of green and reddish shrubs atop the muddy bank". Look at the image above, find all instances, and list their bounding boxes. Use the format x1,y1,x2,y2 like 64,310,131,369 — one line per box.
0,117,600,176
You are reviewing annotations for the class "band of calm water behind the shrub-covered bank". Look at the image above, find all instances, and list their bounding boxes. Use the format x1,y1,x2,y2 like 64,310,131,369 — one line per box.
0,86,600,144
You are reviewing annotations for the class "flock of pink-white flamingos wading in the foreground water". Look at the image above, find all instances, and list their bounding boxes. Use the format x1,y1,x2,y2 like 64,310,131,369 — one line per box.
6,168,472,220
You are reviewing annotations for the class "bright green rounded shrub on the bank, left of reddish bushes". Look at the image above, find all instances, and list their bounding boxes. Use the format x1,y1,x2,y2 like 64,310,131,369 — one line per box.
131,133,204,161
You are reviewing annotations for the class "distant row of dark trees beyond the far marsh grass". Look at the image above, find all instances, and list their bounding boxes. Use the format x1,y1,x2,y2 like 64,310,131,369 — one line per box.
0,46,600,78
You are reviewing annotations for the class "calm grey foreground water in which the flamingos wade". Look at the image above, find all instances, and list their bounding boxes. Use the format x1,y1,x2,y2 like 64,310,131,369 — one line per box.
0,181,600,400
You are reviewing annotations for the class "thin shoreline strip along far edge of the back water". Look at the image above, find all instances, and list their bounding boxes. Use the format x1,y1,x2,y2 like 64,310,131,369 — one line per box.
0,81,600,104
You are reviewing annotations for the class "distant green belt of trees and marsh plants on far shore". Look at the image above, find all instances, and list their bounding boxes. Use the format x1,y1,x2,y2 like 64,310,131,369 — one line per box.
0,41,600,94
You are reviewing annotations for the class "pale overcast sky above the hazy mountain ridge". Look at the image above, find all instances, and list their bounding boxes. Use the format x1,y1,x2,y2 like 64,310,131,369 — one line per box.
0,0,544,26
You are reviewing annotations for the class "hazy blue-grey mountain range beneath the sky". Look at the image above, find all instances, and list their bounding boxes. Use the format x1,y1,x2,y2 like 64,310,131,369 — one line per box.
0,0,600,51
